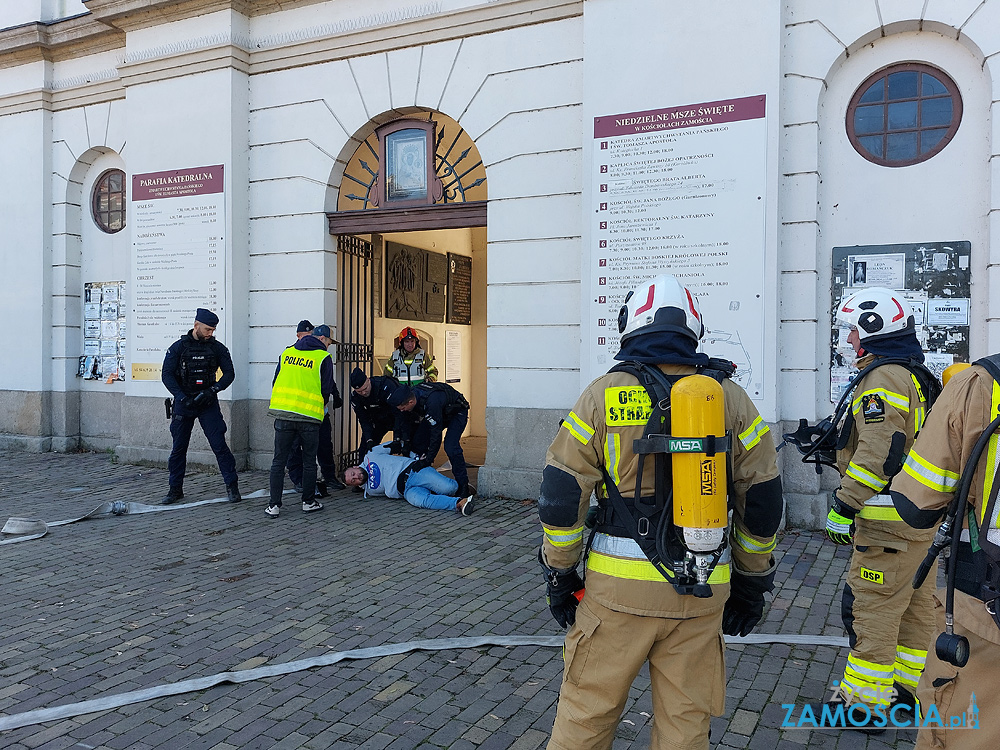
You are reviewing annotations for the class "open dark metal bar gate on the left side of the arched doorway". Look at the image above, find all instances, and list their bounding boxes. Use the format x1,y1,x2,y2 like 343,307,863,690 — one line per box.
333,234,378,472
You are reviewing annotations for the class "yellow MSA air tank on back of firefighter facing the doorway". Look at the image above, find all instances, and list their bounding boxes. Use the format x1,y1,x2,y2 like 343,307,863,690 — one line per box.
670,375,729,552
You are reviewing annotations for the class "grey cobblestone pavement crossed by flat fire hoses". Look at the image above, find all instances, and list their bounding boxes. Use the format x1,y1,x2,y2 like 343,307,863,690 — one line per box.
0,452,914,750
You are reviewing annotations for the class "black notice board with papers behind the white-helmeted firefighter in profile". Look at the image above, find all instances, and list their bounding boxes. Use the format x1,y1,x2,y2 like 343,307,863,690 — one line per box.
830,241,972,403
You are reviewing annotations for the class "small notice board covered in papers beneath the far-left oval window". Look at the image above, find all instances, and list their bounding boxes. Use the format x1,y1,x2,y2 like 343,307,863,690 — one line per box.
76,281,127,383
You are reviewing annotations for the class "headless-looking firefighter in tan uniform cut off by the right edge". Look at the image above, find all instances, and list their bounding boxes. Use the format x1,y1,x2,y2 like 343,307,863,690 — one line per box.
892,362,1000,750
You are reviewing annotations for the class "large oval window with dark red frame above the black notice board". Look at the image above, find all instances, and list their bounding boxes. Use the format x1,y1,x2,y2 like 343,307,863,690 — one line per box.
847,63,962,167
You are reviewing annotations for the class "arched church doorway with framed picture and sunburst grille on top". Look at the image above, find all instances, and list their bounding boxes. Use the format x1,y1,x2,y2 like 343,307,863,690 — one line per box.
327,110,487,488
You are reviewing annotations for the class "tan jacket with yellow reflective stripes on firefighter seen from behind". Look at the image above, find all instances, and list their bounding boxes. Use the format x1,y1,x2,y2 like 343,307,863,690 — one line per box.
539,365,781,617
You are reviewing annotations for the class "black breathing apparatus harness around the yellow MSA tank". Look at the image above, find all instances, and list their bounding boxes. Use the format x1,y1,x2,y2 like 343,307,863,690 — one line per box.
587,357,736,598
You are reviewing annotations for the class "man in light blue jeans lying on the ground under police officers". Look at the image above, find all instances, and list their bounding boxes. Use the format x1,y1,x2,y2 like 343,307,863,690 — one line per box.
344,443,476,516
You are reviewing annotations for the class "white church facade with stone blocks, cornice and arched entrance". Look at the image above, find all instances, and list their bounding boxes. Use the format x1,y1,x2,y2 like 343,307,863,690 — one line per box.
0,0,1000,524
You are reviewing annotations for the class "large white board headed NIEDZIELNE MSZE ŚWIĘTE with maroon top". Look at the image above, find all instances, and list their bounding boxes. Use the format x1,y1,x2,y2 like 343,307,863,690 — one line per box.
584,95,773,401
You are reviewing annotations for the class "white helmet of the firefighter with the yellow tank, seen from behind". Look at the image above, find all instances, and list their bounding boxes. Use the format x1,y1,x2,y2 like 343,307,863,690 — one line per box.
618,274,705,342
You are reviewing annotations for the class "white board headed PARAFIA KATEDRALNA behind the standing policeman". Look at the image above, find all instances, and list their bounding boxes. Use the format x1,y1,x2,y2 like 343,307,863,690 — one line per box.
129,164,226,380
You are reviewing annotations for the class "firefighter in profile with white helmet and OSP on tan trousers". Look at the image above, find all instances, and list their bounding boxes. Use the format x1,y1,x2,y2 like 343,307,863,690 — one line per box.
817,287,938,733
